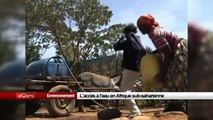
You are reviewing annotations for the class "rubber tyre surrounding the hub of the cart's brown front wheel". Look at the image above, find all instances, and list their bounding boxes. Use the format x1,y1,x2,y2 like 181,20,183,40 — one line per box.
46,85,75,117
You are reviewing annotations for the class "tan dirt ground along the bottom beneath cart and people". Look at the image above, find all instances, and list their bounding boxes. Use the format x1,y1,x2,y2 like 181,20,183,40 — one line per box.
26,108,187,120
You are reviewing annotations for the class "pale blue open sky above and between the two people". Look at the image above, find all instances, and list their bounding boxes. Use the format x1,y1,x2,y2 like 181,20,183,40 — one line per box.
42,0,188,58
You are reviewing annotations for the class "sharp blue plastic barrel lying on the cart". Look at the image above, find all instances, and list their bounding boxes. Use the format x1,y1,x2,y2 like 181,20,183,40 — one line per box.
26,56,70,80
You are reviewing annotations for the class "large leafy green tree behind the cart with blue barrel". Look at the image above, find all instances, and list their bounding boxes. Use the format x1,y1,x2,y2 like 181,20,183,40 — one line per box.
26,0,124,74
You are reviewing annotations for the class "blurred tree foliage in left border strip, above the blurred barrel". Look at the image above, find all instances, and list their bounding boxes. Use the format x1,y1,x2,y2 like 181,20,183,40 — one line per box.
0,0,25,65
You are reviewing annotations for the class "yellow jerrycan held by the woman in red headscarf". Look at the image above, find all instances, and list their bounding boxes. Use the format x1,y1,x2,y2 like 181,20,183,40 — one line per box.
140,54,163,89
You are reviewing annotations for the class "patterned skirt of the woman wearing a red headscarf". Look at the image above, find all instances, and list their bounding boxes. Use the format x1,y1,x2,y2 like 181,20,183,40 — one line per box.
166,39,188,88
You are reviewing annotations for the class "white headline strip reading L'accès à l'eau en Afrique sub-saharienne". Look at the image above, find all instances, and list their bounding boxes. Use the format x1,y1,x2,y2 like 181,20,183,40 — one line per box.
77,92,213,100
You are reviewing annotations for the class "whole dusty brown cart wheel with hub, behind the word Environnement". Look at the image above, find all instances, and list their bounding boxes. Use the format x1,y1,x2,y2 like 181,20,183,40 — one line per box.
46,85,75,117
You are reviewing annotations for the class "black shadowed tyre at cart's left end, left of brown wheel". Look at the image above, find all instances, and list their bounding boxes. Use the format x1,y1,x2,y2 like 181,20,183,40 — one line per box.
25,100,41,116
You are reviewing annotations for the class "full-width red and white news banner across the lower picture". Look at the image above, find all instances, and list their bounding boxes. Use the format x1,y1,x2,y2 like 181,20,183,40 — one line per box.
0,92,213,100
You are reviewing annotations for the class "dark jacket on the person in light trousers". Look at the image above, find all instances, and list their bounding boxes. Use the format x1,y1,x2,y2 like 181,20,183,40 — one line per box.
113,32,146,71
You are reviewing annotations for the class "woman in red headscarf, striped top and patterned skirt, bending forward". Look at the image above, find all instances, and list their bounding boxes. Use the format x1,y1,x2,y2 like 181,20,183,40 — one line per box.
137,14,188,112
